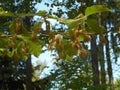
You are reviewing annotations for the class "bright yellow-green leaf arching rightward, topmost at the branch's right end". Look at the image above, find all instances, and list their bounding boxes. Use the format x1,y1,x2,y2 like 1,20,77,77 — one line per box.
85,5,111,17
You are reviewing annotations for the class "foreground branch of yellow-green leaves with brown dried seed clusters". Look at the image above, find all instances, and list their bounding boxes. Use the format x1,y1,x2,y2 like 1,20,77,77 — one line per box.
0,5,110,60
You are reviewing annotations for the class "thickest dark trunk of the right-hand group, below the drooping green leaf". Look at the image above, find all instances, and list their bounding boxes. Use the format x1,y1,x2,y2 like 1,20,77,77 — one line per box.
91,35,100,86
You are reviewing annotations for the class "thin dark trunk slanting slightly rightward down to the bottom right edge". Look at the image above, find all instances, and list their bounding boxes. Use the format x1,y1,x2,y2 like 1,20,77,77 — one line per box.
106,36,114,90
